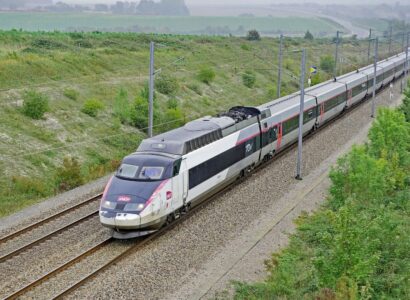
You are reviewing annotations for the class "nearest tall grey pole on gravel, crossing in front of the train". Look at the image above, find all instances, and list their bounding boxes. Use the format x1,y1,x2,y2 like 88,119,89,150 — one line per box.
296,49,306,180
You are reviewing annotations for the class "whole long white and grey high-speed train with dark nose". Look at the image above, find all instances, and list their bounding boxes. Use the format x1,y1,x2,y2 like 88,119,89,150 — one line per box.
100,54,408,239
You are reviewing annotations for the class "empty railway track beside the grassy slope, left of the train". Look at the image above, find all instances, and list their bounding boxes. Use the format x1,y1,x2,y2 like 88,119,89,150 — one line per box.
0,195,101,263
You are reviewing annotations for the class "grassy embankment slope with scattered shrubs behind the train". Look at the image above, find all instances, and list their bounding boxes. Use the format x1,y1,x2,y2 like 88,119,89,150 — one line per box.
0,31,398,216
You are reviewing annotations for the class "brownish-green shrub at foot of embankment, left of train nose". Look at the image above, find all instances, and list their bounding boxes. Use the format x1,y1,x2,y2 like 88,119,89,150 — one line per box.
55,157,84,191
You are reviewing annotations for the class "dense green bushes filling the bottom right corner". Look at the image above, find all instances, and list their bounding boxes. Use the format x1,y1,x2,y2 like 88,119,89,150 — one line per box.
235,94,410,300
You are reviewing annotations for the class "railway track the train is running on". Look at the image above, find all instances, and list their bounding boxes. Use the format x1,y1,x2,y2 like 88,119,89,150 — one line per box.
0,78,398,299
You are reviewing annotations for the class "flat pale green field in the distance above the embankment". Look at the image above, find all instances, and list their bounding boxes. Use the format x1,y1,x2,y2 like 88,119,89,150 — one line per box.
0,12,343,35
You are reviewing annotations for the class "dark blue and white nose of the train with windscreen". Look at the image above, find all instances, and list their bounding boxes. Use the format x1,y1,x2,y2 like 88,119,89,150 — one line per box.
100,153,181,238
